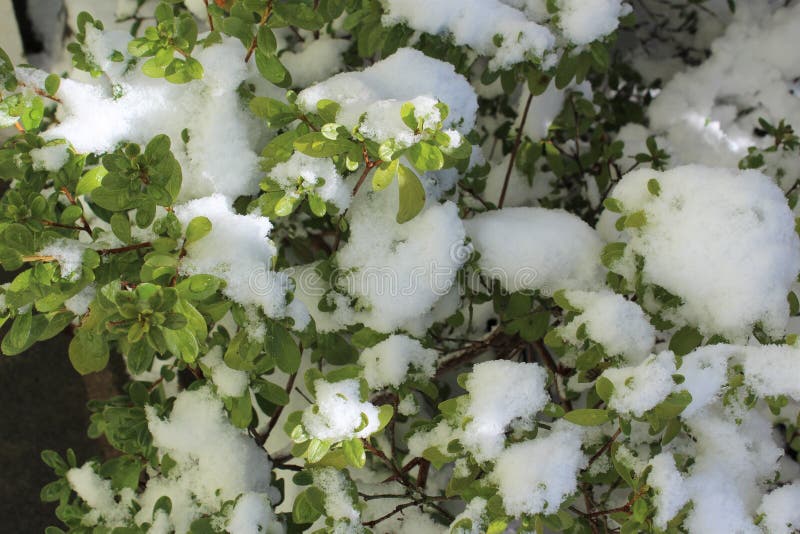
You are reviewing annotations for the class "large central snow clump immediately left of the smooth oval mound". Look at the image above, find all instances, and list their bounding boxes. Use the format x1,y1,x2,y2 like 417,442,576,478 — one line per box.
334,182,468,333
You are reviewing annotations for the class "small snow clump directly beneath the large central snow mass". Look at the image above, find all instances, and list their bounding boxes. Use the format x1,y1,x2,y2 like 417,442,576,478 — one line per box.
358,335,437,392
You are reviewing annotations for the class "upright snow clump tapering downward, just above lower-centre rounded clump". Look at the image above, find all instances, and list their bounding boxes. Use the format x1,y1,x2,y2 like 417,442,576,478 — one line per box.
461,360,550,462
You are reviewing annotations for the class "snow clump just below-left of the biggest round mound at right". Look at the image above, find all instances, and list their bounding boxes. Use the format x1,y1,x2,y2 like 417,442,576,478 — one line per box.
561,291,656,364
